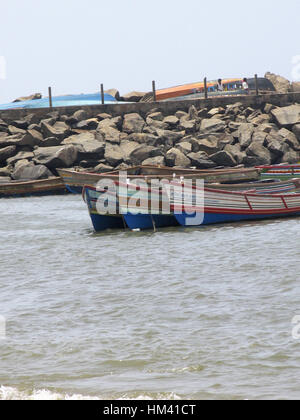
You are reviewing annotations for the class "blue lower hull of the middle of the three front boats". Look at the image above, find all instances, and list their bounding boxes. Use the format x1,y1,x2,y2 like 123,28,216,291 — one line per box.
124,213,178,230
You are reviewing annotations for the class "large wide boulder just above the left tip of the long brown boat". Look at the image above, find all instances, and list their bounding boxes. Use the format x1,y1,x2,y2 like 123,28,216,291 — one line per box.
33,144,78,168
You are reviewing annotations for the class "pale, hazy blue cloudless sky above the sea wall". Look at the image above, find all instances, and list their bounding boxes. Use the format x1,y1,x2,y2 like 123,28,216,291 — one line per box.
0,0,300,103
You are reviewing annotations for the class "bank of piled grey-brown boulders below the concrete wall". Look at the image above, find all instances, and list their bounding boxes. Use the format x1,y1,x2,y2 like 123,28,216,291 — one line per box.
0,102,300,182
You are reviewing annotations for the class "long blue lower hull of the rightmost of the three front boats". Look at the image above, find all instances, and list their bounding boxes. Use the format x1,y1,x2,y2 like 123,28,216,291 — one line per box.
175,213,300,226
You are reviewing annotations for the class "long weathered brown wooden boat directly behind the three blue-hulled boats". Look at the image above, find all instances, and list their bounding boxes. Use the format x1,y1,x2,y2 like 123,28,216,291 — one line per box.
58,166,260,194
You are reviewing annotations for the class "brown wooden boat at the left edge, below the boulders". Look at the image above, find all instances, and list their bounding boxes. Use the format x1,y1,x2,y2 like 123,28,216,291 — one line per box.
0,177,68,197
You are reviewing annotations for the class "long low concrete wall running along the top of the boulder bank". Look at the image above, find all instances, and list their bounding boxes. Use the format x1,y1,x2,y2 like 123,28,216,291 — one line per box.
0,92,300,121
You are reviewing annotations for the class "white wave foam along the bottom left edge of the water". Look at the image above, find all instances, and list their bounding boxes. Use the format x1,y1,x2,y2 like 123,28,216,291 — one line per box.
0,386,181,401
